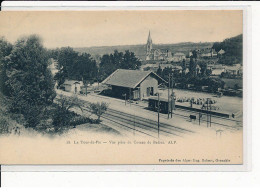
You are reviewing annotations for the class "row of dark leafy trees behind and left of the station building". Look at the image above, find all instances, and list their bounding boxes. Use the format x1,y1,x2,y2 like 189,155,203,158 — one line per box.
49,47,141,86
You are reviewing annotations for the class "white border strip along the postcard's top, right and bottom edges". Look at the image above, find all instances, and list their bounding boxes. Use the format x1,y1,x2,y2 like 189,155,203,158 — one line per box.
2,1,252,172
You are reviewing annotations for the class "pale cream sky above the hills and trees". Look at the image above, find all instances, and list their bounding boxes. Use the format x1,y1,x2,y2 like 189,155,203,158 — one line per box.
0,10,243,48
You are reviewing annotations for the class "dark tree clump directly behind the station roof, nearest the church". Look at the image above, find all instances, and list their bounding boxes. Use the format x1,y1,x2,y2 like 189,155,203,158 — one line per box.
100,50,141,80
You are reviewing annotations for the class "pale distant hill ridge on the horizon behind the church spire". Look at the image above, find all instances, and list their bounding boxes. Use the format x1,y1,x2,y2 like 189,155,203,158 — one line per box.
73,42,214,60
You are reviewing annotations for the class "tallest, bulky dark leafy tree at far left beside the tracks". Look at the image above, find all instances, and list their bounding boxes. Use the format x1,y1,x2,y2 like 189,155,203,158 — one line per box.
5,35,56,127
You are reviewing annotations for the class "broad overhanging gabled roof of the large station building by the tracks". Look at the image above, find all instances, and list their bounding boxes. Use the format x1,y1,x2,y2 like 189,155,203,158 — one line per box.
102,69,167,88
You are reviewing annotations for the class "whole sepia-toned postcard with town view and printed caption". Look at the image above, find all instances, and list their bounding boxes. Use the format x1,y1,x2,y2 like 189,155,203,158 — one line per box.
0,9,244,165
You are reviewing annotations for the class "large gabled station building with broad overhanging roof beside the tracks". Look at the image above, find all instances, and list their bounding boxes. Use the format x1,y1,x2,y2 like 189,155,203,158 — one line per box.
102,69,167,100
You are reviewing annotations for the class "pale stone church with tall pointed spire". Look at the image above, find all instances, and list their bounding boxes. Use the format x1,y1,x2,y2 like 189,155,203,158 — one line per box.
146,31,172,61
